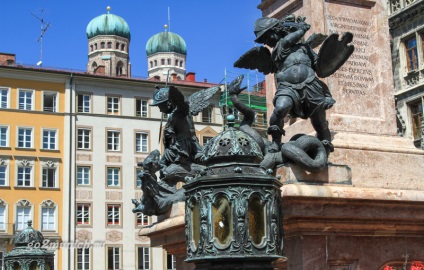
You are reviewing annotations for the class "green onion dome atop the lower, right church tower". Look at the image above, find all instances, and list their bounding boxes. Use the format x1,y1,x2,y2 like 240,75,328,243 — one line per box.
146,25,187,56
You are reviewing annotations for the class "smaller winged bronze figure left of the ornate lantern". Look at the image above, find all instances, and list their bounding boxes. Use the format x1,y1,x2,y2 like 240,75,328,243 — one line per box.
150,86,220,185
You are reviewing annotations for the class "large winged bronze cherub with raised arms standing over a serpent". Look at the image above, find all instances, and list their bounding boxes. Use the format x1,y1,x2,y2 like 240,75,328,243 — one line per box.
234,15,354,155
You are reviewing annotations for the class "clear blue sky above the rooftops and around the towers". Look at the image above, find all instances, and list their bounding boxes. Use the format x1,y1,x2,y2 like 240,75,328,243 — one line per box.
0,0,263,83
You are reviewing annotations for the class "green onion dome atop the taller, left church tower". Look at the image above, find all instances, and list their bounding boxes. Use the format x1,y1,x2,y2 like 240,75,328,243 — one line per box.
86,7,131,40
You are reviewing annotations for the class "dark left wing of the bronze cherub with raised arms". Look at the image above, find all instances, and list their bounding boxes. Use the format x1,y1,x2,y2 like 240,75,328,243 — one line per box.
234,46,277,75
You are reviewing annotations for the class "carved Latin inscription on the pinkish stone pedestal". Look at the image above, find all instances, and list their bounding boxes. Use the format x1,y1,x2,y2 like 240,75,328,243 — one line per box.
326,15,375,96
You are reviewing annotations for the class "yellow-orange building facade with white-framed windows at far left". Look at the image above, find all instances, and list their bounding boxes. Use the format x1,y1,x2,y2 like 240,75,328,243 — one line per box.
0,68,69,269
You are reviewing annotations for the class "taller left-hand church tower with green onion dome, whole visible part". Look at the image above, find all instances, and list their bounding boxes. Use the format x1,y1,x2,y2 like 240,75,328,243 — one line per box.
86,7,131,77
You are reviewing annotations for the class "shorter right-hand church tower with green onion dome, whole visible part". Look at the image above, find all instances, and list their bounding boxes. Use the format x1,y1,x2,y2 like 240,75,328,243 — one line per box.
146,25,187,81
